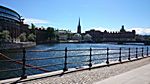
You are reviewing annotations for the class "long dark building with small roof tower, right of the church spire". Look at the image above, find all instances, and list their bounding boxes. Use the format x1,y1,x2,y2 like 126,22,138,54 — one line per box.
85,25,136,42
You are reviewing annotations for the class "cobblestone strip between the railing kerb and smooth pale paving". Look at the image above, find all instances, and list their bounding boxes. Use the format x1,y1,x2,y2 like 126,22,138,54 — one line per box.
22,58,150,84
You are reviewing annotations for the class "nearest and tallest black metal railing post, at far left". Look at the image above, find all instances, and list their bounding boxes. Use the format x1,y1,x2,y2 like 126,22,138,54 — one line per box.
21,48,27,79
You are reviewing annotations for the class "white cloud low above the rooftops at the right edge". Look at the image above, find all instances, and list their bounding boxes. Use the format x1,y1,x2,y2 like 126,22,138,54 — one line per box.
127,28,150,35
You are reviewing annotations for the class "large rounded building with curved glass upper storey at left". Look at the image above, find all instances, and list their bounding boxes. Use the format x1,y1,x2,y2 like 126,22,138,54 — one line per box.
0,6,28,42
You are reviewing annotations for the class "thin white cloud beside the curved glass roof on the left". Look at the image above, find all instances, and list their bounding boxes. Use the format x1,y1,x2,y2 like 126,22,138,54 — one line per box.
24,18,49,24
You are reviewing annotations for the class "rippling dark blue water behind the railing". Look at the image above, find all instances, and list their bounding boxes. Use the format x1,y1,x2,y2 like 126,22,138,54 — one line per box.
0,43,147,79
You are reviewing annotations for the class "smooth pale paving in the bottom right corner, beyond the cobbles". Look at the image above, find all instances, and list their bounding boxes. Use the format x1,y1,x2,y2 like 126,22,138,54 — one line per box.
94,64,150,84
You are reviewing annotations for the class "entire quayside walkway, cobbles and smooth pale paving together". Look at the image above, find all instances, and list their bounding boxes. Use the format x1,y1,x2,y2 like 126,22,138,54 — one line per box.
23,57,150,84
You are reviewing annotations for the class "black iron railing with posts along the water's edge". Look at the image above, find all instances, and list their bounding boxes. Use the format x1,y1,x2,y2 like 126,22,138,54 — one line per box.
0,47,149,79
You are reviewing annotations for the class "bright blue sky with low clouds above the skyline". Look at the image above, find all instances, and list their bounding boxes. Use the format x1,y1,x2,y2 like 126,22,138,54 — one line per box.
0,0,150,34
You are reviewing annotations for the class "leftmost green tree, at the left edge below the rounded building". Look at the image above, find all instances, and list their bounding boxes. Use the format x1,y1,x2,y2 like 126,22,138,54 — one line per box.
0,30,11,42
